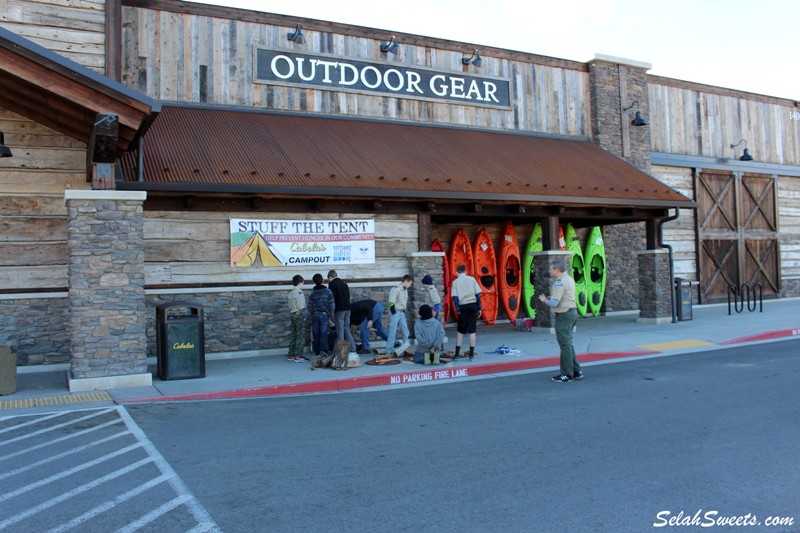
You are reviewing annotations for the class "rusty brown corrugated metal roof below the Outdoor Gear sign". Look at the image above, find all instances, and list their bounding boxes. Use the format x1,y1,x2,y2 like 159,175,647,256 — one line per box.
117,106,694,207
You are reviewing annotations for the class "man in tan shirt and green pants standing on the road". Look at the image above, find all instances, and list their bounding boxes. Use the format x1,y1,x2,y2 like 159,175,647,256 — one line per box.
539,259,583,383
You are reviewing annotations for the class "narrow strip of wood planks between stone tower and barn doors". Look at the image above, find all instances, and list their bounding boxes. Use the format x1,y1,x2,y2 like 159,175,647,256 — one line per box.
650,165,697,281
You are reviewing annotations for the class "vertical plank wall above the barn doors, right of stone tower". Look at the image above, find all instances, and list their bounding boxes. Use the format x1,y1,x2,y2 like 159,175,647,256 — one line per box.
648,83,800,165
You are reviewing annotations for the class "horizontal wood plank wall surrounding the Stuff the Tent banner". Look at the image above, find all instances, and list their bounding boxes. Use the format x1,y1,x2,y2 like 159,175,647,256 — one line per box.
144,211,418,285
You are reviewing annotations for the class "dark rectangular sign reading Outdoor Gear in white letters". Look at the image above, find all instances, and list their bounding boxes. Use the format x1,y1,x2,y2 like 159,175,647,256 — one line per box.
256,48,511,109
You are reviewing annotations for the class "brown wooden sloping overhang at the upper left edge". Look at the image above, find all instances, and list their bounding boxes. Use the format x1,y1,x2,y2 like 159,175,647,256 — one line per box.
0,27,159,153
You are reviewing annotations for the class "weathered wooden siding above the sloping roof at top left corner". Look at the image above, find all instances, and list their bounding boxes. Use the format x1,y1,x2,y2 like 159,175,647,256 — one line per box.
0,0,106,73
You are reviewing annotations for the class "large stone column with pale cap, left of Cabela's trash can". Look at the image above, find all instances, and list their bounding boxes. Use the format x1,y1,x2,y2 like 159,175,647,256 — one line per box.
64,190,152,392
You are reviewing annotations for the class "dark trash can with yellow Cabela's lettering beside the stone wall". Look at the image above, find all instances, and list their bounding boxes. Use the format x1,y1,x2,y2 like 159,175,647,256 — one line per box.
156,302,206,380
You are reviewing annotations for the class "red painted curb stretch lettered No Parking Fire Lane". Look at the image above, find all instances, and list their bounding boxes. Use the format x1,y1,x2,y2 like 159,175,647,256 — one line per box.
117,350,660,403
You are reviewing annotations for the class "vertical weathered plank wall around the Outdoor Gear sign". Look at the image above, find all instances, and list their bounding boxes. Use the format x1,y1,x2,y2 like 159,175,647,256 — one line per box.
122,7,591,138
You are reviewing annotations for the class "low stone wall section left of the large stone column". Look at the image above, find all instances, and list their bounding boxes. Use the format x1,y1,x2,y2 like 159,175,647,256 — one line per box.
0,297,70,366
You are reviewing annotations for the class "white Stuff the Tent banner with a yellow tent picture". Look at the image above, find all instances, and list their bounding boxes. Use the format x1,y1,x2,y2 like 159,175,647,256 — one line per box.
230,218,375,267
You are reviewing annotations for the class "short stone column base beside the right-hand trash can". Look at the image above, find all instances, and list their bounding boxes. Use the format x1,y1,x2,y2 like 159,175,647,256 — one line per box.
636,250,673,324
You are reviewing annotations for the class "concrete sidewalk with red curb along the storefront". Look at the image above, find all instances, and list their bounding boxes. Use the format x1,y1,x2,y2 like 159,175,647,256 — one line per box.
0,298,800,416
